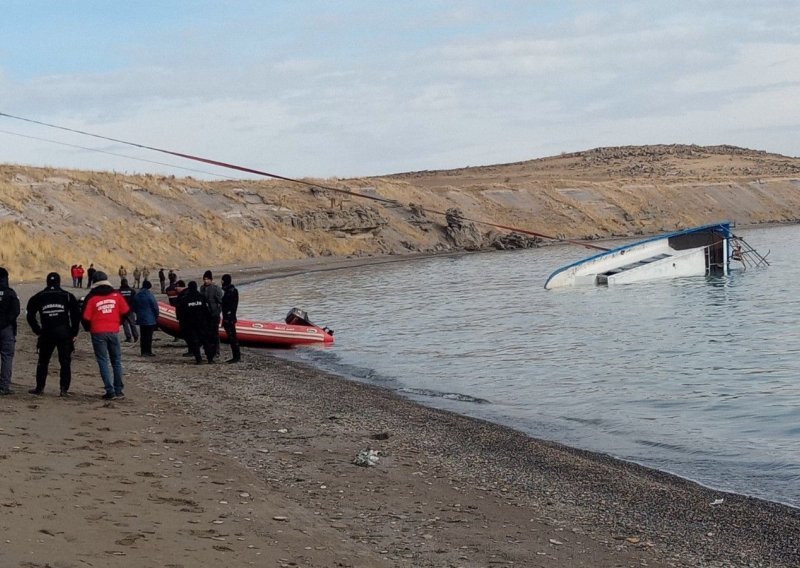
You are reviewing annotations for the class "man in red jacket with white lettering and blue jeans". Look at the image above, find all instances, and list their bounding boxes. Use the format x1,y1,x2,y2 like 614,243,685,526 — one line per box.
83,271,130,400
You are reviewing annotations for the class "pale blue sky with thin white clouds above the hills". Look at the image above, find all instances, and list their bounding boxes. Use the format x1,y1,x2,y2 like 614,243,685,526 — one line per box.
0,0,800,179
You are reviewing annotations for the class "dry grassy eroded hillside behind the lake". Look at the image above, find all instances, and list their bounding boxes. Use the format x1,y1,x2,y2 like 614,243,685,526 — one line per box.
0,145,800,280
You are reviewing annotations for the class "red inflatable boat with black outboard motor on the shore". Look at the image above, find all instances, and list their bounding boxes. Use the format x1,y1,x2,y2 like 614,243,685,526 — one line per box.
158,302,333,347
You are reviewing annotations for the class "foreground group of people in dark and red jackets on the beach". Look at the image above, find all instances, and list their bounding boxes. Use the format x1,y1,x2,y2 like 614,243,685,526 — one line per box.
0,266,241,400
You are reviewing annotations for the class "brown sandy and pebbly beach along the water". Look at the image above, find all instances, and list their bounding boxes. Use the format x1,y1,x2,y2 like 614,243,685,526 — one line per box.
0,257,800,568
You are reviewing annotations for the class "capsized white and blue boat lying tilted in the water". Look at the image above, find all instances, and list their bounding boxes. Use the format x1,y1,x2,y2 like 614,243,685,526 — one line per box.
544,222,769,290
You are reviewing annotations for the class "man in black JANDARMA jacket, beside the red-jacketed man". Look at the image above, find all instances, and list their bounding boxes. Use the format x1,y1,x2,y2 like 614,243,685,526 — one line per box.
26,272,81,396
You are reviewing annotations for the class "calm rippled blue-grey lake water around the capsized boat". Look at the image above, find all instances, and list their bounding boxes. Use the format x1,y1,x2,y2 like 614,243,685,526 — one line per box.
241,226,800,506
